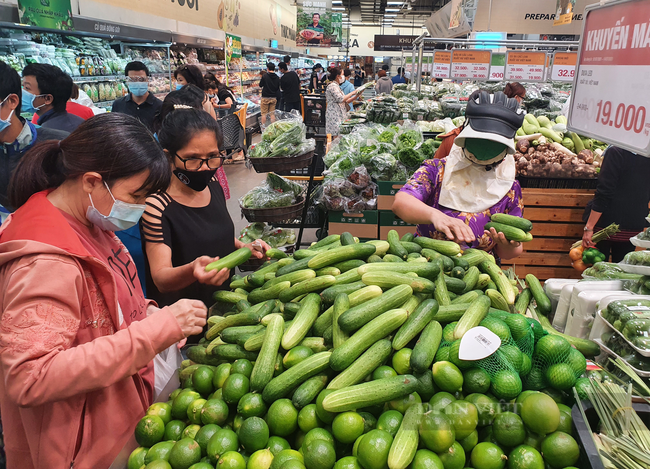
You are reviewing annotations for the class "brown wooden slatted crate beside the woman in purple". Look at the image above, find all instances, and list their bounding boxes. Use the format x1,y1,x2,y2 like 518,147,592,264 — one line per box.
502,189,595,281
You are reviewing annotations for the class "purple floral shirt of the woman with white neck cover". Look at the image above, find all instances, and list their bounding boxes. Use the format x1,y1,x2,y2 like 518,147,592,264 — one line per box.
400,159,524,251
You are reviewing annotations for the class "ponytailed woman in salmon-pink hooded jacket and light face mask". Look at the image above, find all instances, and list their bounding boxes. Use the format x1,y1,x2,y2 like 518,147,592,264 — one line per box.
0,113,206,469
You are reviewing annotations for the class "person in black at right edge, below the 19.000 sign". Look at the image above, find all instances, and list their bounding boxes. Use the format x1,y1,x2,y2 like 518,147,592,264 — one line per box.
582,147,650,262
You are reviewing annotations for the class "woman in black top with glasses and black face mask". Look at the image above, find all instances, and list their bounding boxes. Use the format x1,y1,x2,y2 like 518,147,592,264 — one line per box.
141,105,269,342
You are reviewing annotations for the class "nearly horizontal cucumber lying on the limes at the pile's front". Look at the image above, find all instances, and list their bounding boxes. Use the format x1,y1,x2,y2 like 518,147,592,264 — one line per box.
323,375,418,412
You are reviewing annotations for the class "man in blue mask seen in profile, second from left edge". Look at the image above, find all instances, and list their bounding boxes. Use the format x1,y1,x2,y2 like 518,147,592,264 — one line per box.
22,64,84,132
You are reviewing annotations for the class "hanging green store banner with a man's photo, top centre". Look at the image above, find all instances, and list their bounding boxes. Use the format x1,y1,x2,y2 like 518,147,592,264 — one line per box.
296,0,343,47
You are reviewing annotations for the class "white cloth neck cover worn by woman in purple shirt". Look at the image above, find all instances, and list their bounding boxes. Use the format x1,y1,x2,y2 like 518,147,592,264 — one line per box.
440,145,516,213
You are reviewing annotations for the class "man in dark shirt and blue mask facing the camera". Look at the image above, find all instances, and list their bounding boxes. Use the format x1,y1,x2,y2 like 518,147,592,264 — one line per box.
111,60,162,132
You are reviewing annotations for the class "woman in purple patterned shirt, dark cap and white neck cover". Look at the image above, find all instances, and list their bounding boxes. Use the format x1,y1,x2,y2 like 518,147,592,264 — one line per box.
393,91,523,259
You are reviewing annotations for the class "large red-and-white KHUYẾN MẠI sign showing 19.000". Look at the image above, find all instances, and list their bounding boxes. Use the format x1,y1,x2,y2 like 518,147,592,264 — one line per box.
568,0,650,156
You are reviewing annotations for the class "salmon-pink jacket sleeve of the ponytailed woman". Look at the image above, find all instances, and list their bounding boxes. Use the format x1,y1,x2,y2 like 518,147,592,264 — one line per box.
0,255,184,406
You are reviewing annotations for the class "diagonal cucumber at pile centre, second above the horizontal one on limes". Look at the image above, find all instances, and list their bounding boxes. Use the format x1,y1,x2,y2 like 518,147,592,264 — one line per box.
330,309,408,371
